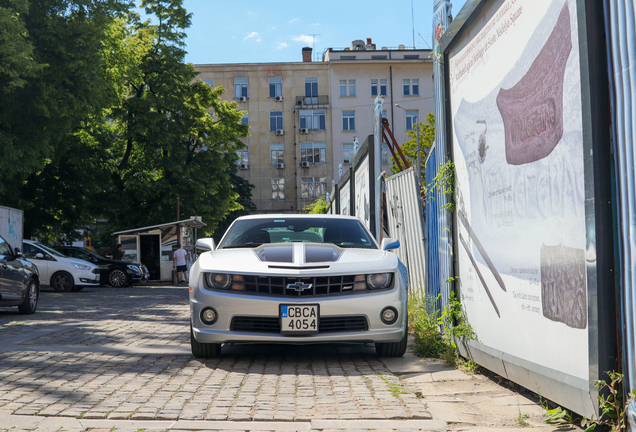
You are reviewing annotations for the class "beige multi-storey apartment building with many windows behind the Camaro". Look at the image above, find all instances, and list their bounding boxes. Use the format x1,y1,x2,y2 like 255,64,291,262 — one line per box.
195,40,433,213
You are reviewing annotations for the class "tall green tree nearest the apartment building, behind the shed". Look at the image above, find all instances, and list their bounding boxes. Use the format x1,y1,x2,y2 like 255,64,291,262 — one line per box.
96,0,249,234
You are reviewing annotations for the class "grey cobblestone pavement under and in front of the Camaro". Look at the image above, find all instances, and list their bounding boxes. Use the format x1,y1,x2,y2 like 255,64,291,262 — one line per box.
0,286,430,429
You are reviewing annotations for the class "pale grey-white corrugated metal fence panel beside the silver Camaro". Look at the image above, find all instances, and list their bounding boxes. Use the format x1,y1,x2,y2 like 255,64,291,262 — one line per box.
386,168,426,295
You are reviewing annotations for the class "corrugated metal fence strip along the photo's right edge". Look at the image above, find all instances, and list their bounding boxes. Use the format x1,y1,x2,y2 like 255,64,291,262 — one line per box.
604,0,636,431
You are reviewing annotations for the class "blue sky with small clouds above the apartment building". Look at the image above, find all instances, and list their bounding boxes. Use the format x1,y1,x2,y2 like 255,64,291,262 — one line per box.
176,0,466,64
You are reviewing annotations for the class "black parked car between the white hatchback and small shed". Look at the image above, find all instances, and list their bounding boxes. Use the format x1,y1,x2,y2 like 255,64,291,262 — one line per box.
54,246,149,288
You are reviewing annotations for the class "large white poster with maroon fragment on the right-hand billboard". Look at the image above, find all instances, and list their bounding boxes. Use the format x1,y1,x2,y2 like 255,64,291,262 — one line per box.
448,0,589,380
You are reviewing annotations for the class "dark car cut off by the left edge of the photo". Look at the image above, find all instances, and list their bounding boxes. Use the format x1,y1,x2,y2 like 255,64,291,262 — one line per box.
0,237,40,314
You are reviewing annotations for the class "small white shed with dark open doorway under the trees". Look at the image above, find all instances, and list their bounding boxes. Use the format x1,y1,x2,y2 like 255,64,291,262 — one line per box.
113,216,207,281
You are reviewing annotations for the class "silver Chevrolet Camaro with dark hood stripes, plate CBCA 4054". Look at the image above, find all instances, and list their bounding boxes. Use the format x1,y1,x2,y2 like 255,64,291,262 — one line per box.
190,215,408,358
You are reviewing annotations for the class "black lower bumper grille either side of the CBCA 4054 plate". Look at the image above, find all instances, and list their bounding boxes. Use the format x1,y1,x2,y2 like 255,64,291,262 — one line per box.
230,316,369,333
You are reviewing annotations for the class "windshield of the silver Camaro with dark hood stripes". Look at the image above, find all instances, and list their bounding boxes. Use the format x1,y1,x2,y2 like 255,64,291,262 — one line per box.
219,217,377,249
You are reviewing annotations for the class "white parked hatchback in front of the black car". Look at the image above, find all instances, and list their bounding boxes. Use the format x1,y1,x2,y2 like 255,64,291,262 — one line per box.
22,240,99,292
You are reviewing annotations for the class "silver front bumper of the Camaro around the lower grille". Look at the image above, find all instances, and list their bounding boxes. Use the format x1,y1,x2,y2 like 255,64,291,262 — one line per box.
190,284,407,344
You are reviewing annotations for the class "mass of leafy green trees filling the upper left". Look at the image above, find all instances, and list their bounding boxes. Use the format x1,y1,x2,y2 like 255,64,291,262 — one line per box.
0,0,251,240
